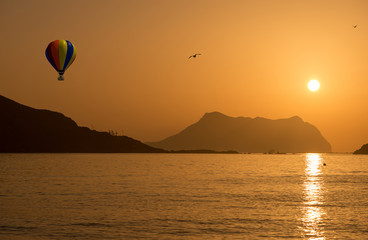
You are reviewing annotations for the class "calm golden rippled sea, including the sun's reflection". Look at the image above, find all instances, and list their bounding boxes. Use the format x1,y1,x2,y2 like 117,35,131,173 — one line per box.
0,154,368,240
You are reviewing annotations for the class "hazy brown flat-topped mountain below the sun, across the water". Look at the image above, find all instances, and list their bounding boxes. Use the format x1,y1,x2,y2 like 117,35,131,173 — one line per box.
147,112,331,153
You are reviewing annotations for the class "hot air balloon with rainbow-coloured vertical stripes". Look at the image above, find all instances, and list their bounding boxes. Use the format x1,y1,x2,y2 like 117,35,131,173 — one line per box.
45,40,77,81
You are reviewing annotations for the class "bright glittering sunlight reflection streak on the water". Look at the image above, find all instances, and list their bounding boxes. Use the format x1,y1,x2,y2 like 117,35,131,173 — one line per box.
301,153,326,240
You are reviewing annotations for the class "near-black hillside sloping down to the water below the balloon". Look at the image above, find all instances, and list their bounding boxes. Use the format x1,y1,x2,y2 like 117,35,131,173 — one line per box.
0,95,165,153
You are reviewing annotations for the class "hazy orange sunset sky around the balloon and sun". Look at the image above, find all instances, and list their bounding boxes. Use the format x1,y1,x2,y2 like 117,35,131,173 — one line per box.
0,0,368,152
